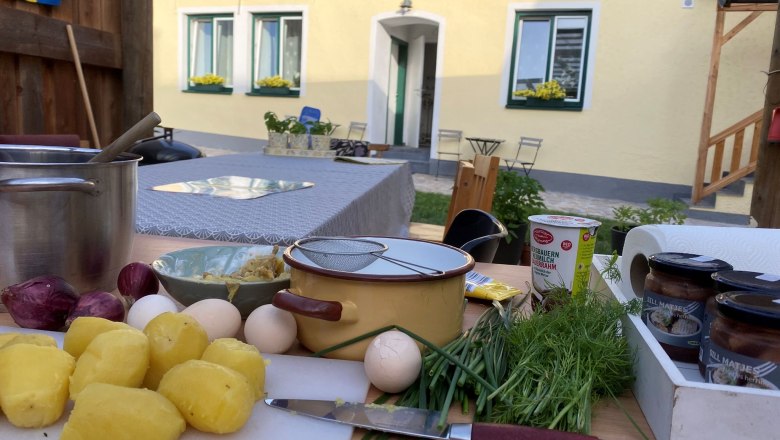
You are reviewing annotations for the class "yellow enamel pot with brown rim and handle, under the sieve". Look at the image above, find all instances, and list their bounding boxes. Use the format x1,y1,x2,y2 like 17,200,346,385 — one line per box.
273,237,474,360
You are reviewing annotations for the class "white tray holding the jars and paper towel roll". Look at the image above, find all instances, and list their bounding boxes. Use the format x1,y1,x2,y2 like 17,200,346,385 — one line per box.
591,255,780,440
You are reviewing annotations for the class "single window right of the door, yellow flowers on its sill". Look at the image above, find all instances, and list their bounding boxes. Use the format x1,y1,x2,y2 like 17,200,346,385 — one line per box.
507,10,591,109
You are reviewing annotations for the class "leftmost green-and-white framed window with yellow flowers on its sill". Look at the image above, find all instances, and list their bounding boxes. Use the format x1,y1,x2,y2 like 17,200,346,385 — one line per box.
187,14,233,88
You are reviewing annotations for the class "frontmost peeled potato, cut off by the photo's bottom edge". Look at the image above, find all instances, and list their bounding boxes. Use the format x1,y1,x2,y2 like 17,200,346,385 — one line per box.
60,383,187,440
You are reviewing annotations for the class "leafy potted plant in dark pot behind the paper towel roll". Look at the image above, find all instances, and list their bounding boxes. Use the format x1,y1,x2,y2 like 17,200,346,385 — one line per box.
610,197,688,255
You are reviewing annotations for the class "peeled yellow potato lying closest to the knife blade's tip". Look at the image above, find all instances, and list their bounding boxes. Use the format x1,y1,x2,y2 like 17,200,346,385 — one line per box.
157,360,255,434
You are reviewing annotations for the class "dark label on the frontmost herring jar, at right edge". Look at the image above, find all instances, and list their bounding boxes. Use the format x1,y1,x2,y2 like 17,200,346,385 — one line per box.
704,339,780,390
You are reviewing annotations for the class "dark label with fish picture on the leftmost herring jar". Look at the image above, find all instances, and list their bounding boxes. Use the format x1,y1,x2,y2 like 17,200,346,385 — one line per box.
642,289,704,348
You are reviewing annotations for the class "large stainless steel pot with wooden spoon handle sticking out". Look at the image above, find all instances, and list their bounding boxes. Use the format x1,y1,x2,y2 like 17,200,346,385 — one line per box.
0,145,140,292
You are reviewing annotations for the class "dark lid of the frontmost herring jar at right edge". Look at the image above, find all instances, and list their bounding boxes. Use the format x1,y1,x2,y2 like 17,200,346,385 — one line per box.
715,291,780,328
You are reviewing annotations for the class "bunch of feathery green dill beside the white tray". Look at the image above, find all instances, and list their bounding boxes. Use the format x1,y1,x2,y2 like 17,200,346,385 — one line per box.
490,289,641,433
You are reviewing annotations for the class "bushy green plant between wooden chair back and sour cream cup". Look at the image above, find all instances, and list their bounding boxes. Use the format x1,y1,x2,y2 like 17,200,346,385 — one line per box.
492,170,546,242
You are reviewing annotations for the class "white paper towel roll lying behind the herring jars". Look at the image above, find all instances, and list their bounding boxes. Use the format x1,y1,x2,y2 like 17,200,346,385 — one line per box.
620,225,780,298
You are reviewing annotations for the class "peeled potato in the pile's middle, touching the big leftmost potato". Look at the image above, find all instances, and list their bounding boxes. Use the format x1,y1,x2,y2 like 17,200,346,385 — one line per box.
70,328,149,400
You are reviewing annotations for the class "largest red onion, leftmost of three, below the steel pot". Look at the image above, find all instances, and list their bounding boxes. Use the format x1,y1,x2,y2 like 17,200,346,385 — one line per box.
0,275,79,330
